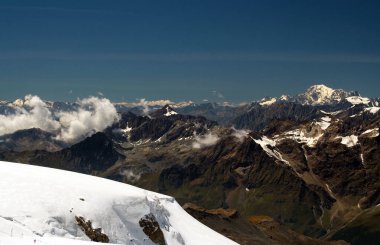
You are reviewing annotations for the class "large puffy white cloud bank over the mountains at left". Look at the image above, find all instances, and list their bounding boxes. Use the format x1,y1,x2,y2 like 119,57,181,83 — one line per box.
0,95,118,143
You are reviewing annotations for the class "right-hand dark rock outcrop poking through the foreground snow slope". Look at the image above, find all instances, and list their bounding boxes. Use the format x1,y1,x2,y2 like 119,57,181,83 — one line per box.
139,214,166,245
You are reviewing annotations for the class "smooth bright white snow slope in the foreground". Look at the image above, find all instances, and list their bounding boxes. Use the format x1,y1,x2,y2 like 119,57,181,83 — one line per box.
0,161,236,245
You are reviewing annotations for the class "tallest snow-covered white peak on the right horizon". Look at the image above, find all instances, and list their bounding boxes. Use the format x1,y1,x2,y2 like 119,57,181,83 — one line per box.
295,84,359,105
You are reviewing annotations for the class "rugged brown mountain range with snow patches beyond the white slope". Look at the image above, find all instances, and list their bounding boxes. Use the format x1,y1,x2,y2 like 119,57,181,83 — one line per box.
0,85,380,244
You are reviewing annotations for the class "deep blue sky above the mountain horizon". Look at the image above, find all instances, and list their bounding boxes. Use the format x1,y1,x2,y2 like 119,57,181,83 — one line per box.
0,0,380,102
